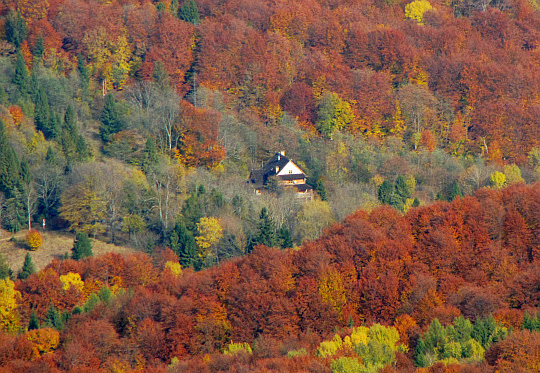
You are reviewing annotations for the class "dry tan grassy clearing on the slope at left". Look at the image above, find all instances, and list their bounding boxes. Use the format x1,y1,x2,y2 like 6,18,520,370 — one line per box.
0,230,136,273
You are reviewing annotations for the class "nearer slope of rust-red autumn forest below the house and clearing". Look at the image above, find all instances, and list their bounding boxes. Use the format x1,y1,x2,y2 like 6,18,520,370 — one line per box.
0,184,540,372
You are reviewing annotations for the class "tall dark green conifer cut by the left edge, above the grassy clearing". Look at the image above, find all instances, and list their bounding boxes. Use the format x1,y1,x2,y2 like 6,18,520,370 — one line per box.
0,120,20,198
